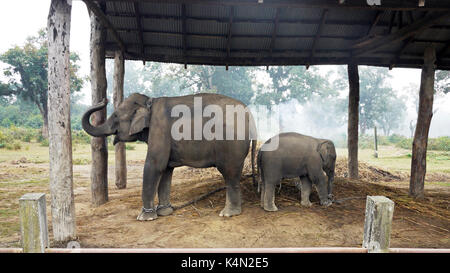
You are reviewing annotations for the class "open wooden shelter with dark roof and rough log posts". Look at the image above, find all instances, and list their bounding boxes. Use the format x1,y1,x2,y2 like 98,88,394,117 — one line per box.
48,0,450,240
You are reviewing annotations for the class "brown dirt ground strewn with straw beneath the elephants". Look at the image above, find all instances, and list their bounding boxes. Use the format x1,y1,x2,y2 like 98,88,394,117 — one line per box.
0,155,450,248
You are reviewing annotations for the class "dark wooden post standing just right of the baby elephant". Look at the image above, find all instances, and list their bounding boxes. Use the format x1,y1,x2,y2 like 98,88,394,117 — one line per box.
347,63,359,179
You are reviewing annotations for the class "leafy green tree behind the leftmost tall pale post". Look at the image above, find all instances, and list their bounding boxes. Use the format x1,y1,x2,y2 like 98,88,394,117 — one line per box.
0,30,84,137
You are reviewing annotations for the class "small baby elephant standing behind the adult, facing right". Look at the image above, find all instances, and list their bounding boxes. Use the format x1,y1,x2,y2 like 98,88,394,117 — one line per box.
258,133,336,211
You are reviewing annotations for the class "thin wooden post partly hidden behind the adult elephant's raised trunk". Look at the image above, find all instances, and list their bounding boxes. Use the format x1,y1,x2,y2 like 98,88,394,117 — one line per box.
113,51,127,189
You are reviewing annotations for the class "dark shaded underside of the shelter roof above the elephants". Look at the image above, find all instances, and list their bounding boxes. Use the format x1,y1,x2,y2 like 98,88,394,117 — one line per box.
85,0,450,70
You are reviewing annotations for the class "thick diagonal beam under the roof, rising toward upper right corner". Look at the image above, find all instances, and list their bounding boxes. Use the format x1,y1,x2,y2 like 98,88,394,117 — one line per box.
352,11,450,57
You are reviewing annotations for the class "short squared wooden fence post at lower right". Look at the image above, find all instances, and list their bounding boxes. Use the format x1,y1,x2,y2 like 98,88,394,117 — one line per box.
362,196,394,253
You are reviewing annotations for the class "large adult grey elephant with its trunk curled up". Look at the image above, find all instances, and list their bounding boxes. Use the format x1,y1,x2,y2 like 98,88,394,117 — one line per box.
82,93,256,221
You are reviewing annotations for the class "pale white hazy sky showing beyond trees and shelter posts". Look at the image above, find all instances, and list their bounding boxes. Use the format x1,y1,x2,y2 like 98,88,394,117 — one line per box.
0,0,450,135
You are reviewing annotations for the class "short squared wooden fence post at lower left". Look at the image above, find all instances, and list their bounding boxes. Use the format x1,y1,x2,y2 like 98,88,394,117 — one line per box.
19,193,49,253
